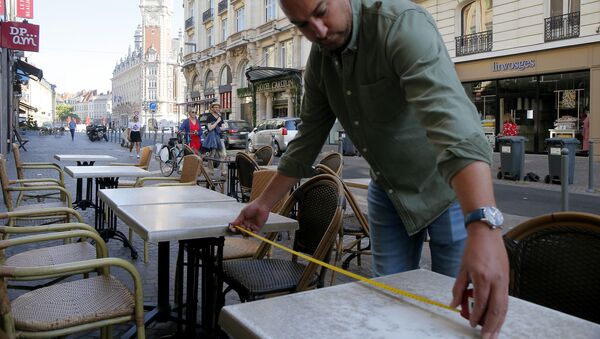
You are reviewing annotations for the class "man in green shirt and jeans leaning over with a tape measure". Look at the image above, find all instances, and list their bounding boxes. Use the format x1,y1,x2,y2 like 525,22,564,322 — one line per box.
230,0,508,337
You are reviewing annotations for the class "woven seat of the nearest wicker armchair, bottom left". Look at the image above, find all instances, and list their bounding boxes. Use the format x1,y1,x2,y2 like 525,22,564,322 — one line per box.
12,276,134,331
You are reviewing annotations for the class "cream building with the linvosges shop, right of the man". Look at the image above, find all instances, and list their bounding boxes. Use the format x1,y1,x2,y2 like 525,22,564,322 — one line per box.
417,0,600,153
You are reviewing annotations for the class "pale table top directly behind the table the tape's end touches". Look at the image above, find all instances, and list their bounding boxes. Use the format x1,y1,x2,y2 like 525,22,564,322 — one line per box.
98,186,236,209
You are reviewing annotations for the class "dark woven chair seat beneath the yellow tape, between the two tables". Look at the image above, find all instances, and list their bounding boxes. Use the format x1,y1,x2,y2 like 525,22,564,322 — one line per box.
223,259,306,295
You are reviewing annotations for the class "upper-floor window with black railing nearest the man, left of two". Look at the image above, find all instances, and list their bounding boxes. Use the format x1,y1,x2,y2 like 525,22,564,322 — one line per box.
455,0,492,56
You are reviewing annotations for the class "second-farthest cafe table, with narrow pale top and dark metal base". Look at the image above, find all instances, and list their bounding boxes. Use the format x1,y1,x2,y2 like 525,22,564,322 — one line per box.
65,165,150,259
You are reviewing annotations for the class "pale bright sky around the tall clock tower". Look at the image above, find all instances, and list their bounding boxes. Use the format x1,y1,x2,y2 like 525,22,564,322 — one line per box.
26,0,183,93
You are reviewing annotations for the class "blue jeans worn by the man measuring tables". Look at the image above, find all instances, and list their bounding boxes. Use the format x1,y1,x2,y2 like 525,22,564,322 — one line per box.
367,182,467,277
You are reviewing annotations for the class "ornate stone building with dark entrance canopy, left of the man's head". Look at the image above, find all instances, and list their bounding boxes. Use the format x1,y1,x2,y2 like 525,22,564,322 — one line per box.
183,0,310,123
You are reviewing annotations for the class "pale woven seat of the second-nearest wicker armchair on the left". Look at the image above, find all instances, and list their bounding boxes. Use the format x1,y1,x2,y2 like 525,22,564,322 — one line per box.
5,241,96,267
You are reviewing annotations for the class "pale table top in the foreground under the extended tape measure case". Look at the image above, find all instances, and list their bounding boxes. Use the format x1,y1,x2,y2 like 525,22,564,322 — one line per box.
219,270,600,339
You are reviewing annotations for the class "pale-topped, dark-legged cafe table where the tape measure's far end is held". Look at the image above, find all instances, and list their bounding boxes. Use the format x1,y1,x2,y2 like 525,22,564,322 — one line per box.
99,187,298,338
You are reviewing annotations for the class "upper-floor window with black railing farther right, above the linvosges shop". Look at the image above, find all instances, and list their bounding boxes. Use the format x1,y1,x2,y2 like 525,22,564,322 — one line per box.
544,0,580,42
